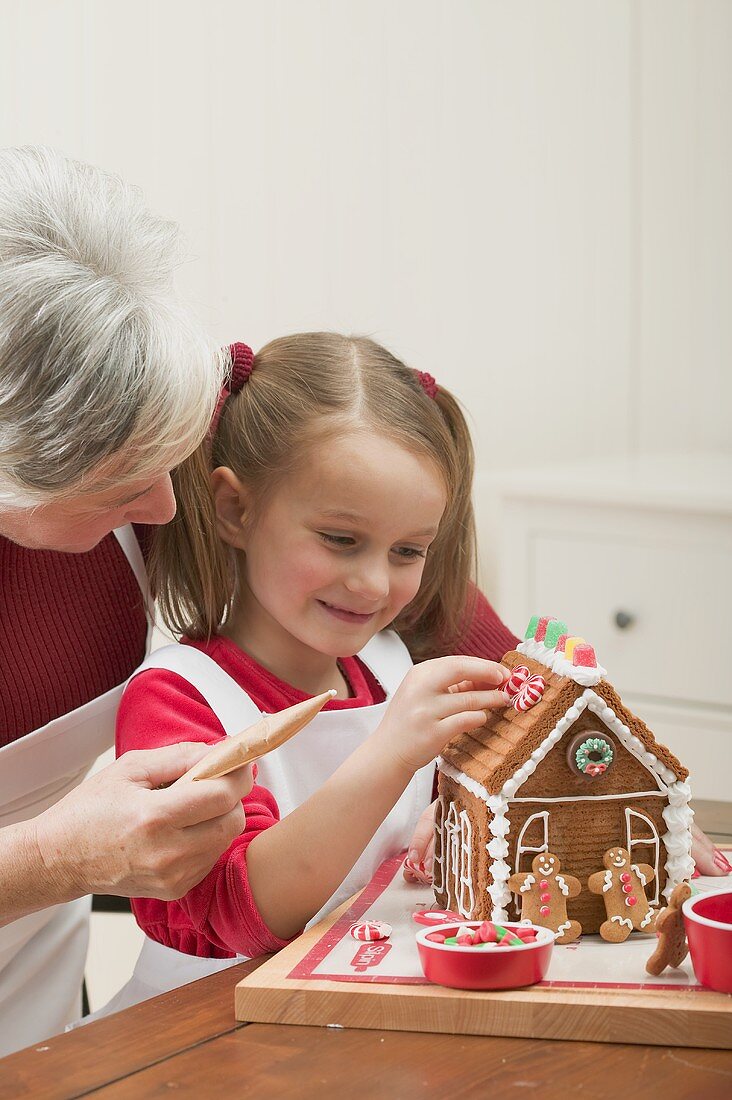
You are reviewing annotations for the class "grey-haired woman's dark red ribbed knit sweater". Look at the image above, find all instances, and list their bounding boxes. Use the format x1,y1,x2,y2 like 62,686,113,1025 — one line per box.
0,528,517,746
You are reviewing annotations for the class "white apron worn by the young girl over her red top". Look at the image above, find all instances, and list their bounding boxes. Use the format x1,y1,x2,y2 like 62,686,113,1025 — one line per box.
93,630,435,1023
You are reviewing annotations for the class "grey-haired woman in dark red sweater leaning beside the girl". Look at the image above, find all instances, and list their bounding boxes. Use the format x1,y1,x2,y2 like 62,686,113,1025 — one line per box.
0,149,254,1055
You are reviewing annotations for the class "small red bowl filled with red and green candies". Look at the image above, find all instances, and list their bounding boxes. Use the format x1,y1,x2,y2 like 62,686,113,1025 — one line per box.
417,921,554,989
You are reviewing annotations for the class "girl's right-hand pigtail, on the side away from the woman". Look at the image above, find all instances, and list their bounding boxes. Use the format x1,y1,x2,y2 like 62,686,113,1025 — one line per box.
394,383,477,661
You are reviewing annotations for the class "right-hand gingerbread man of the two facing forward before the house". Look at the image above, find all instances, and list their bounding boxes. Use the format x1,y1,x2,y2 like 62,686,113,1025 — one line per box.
587,847,657,944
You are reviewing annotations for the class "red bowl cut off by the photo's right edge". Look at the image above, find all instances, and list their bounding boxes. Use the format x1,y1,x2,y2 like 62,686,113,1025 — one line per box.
682,890,732,993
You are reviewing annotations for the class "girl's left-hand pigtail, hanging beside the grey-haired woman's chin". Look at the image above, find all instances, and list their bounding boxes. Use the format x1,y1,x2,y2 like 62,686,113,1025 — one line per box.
150,441,236,639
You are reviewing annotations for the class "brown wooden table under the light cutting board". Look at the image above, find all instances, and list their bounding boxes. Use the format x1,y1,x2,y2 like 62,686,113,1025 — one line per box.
0,807,732,1100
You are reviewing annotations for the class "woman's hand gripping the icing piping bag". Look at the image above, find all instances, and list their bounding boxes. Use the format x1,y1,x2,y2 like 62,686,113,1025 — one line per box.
29,744,253,901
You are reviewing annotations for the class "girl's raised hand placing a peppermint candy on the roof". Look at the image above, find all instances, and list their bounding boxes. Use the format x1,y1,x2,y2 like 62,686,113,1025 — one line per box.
378,657,510,773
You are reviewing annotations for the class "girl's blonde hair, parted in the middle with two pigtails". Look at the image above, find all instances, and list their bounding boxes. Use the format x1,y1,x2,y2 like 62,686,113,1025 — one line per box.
151,332,476,659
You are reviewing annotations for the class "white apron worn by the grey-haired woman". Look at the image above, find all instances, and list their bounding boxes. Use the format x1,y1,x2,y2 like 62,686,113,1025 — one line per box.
0,527,152,1057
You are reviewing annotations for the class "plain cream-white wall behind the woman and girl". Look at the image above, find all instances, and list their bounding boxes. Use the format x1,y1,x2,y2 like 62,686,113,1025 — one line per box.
0,0,732,594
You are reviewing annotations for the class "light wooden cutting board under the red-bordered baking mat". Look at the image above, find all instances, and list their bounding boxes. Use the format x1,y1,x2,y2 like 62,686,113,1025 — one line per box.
236,895,732,1049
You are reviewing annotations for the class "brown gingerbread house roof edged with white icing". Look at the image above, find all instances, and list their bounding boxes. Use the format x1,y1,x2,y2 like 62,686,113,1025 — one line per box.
441,650,689,794
